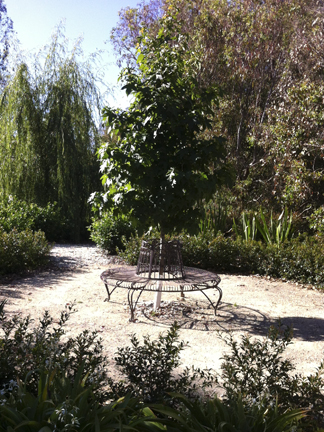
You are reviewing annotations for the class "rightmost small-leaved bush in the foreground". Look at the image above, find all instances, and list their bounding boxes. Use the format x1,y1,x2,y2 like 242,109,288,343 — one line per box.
221,323,324,430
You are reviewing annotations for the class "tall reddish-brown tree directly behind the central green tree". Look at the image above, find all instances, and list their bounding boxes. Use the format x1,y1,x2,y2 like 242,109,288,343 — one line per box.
112,0,302,184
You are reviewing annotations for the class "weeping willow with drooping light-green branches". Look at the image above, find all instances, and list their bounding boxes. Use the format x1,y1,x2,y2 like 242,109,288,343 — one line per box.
0,31,104,241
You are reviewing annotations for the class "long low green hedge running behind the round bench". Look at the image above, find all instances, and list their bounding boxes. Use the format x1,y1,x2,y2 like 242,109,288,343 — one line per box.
119,233,324,287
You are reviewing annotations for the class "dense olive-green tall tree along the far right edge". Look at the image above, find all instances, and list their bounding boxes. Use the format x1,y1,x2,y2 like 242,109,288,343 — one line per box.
261,2,324,214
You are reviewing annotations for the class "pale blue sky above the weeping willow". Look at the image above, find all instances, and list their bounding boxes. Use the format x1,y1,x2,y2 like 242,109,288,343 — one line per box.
5,0,140,108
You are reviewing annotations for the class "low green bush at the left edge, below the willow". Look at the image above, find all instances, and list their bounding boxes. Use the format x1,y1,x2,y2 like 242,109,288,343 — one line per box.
0,229,51,275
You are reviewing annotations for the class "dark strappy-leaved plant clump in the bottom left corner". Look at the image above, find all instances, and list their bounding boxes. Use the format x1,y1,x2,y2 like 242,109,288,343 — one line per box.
0,364,157,432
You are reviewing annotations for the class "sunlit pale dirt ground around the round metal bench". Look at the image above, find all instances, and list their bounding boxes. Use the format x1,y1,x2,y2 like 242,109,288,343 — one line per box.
0,246,324,375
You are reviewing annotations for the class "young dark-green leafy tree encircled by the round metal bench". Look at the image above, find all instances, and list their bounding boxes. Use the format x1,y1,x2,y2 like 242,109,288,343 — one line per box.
99,8,230,238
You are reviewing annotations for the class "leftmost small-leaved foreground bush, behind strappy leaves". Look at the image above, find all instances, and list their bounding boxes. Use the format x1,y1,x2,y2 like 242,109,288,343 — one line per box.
0,305,107,395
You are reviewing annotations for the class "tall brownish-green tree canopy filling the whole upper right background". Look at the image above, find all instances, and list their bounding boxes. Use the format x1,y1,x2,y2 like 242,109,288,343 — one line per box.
112,0,324,223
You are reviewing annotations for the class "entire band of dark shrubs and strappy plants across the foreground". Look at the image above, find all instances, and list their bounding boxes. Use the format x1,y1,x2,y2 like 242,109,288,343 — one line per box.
0,303,324,432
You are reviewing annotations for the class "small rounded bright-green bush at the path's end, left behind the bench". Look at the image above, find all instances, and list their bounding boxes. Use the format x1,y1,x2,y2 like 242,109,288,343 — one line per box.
89,212,135,255
